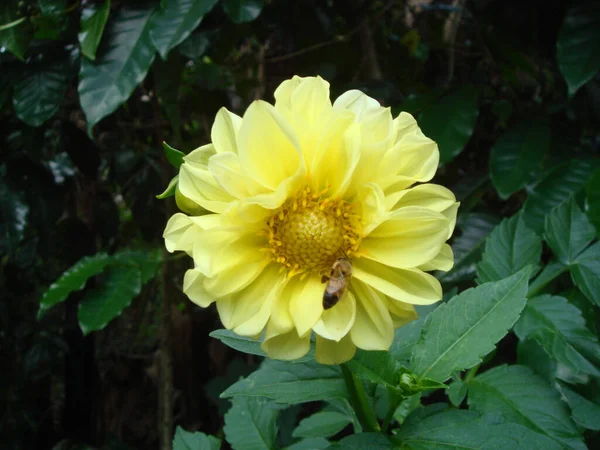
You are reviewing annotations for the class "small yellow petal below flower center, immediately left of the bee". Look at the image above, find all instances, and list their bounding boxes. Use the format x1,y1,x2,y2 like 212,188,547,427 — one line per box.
288,274,325,336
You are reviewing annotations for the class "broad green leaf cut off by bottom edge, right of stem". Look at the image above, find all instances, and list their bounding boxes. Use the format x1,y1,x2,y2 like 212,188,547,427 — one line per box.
396,405,561,450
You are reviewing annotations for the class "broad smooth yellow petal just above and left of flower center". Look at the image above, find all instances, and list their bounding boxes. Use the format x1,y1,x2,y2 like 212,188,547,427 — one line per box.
238,101,305,191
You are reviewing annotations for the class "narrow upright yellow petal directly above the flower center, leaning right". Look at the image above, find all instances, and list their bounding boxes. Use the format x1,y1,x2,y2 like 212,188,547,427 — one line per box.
311,111,361,197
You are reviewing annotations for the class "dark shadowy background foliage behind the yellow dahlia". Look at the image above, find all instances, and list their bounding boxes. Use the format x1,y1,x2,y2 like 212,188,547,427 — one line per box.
0,0,600,449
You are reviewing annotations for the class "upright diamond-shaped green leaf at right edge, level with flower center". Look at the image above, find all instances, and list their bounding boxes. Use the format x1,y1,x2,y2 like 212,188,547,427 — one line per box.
544,198,596,265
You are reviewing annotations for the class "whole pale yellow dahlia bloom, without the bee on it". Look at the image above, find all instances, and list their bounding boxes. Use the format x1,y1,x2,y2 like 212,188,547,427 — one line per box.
164,77,458,364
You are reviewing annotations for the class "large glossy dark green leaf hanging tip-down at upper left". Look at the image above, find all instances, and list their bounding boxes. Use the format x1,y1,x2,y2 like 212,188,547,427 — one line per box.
79,7,154,134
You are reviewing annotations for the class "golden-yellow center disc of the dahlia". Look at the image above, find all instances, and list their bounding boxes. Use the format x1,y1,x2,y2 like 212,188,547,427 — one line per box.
265,188,360,276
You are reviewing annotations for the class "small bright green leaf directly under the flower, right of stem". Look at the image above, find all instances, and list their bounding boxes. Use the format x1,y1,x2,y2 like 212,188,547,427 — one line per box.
346,349,398,387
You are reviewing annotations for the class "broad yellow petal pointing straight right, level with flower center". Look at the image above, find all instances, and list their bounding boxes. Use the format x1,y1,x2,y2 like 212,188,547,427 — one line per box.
359,206,448,269
